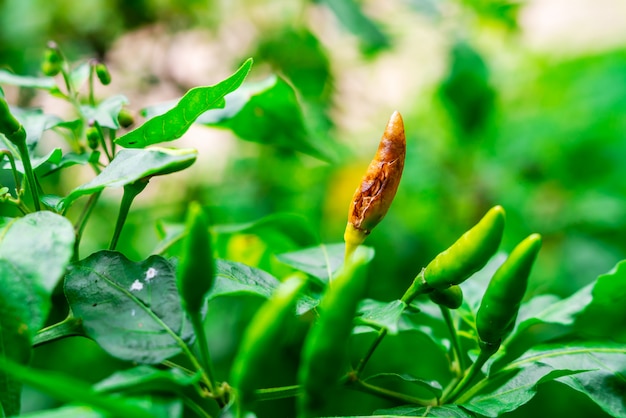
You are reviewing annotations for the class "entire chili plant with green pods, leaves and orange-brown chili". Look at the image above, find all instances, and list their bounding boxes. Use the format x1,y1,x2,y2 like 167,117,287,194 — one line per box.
0,43,626,417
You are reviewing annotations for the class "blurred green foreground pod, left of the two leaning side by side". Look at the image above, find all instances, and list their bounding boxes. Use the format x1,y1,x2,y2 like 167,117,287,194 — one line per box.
230,274,306,409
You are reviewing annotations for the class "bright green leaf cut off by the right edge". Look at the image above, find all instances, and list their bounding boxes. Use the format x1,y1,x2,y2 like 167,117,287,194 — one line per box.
575,261,626,343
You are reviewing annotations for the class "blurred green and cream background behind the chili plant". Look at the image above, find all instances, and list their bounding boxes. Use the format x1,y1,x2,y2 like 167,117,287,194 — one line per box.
0,0,626,416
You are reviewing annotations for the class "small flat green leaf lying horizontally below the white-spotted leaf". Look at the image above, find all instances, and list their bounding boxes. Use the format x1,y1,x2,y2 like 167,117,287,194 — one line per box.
94,366,200,393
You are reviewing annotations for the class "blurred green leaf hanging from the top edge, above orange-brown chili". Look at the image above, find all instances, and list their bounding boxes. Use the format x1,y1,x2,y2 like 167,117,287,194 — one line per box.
318,0,390,54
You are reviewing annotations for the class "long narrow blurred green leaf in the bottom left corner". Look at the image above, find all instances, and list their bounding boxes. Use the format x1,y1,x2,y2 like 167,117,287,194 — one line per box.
0,357,153,418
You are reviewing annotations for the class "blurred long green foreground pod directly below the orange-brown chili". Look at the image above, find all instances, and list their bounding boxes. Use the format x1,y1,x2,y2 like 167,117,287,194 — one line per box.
298,247,373,417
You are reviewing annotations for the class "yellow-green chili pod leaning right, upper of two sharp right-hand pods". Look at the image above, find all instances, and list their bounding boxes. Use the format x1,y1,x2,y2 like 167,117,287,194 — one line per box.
424,206,504,289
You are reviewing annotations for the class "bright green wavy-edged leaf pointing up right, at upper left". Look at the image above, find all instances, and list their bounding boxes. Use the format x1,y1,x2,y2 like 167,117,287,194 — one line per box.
115,58,252,148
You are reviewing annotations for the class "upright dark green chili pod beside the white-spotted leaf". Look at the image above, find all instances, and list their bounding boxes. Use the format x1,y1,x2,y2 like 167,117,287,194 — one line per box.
176,202,215,314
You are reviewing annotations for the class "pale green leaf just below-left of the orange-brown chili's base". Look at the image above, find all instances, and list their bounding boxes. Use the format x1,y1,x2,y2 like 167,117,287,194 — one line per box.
276,243,345,284
